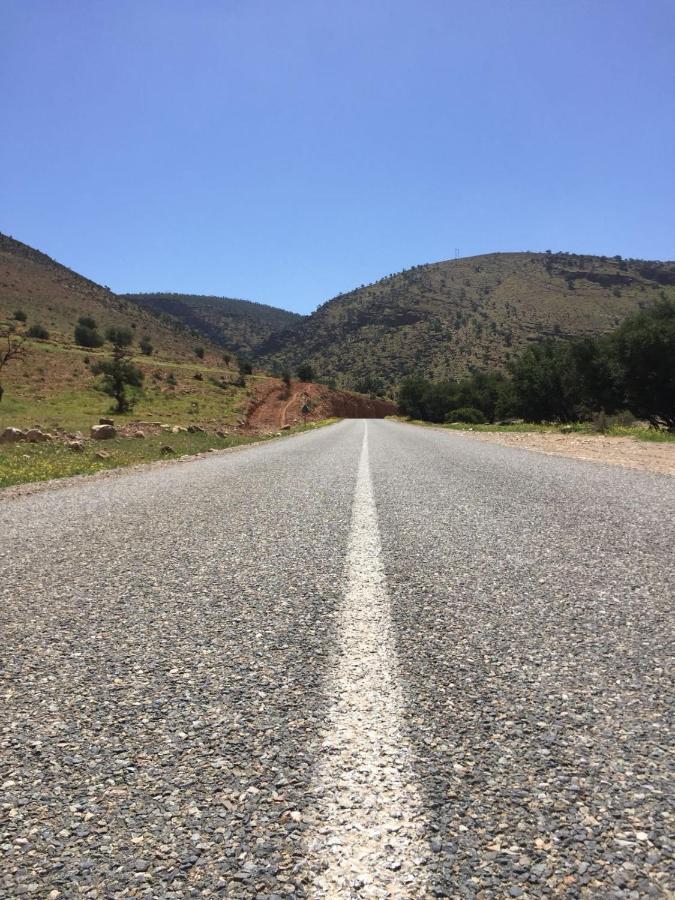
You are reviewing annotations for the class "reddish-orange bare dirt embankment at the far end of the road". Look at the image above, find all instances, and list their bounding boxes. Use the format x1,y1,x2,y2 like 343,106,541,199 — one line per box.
246,378,397,432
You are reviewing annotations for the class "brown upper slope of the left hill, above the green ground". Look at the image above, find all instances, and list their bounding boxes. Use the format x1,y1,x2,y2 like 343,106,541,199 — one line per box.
0,234,215,360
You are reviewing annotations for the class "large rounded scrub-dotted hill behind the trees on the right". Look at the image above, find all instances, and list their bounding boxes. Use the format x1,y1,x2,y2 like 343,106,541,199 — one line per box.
258,253,675,387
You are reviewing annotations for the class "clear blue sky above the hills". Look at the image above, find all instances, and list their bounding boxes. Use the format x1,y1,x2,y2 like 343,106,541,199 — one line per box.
0,0,675,312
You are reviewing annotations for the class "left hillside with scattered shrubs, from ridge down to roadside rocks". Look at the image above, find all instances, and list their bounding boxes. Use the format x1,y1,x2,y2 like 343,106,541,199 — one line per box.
0,235,256,430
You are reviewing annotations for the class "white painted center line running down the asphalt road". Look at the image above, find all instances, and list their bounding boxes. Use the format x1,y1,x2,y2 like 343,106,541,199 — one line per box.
307,424,428,898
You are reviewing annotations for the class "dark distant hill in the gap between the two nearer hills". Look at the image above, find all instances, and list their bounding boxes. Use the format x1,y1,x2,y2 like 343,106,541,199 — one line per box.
120,294,302,356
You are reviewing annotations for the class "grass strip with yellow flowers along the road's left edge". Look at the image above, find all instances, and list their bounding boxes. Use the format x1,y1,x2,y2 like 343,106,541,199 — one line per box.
0,419,337,488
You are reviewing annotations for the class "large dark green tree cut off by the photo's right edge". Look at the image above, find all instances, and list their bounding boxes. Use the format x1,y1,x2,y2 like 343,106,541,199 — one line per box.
611,300,675,431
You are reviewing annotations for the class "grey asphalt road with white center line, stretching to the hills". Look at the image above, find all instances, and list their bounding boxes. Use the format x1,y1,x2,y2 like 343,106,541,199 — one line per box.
0,421,675,900
